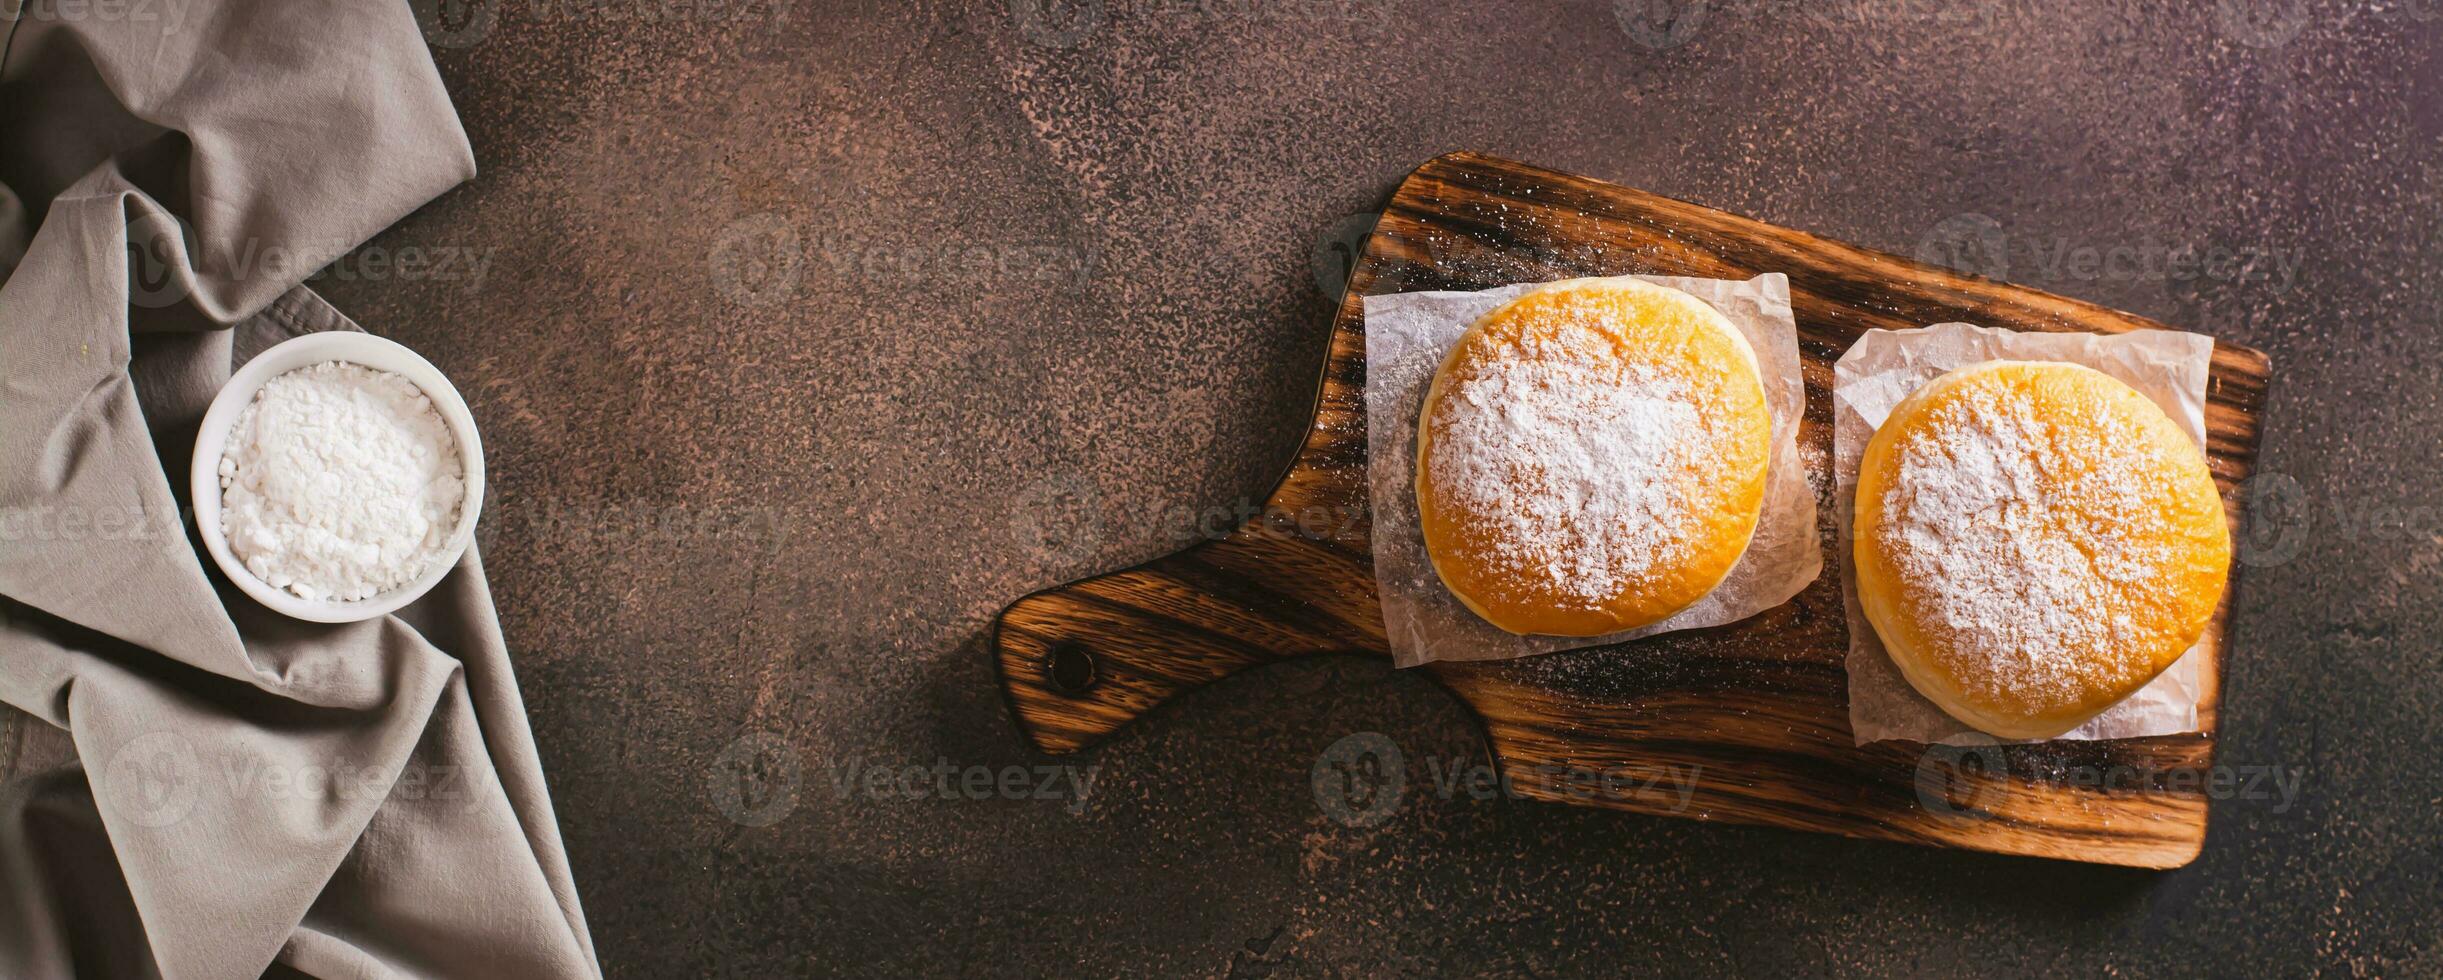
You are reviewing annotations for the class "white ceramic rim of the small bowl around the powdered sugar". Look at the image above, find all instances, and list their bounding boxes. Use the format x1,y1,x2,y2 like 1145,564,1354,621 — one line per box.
188,330,484,623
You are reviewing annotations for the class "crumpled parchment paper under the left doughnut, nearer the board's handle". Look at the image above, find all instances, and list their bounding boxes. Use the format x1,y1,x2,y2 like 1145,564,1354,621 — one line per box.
1366,274,1822,667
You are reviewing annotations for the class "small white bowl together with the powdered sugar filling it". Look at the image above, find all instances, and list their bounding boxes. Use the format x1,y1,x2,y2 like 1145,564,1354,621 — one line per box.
191,330,484,623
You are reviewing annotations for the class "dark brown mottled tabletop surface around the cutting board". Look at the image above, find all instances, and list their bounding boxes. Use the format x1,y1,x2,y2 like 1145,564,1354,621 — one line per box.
320,0,2443,978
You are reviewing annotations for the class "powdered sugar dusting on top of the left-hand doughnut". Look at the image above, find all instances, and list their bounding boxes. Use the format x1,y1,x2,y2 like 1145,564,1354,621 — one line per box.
1432,335,1710,609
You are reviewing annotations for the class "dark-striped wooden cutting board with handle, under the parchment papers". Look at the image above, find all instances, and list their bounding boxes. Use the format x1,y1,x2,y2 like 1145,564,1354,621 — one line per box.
992,154,2267,868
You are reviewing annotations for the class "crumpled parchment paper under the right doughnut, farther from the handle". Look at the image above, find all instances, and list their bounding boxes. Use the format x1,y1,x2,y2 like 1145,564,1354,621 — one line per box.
1832,323,2218,745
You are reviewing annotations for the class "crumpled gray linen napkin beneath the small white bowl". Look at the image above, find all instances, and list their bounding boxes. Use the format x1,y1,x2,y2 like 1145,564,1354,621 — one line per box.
0,0,601,978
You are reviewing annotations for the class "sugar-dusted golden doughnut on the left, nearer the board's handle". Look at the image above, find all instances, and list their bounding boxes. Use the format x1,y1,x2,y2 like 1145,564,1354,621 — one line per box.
1417,279,1774,635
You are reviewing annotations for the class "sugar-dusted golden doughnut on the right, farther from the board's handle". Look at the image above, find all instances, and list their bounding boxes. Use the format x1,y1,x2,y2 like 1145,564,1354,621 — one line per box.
1854,362,2230,738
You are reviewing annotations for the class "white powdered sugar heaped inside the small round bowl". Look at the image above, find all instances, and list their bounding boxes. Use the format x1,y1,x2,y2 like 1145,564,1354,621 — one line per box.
220,362,467,601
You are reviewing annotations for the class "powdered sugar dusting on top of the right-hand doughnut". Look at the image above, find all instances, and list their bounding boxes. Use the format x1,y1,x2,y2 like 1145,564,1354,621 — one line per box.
1881,386,2172,699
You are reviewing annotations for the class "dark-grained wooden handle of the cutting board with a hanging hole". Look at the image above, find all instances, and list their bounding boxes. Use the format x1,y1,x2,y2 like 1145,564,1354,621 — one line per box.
992,503,1383,753
